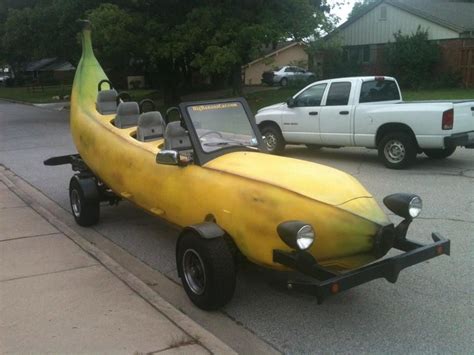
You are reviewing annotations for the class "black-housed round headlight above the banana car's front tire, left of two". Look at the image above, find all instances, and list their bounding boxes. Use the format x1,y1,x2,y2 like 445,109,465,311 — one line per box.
277,221,316,250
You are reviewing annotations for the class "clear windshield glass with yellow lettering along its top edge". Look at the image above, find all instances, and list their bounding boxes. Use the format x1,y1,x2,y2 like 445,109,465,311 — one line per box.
187,102,258,153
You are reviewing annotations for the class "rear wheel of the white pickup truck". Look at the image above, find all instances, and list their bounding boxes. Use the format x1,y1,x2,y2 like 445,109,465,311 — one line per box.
378,132,416,169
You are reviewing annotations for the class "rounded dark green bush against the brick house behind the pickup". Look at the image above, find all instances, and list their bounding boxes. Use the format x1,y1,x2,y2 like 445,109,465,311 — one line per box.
386,27,440,88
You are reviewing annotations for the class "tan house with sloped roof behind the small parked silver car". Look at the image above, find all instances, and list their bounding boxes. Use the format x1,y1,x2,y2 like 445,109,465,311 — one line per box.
242,42,308,85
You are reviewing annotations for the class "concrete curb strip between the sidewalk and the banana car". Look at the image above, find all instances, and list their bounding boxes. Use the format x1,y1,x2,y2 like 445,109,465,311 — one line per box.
0,165,236,354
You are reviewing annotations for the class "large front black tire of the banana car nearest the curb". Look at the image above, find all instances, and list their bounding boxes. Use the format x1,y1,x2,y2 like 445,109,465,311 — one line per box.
176,232,236,310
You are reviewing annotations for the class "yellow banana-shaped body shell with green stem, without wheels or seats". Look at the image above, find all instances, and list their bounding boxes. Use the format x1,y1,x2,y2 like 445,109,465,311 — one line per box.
71,30,390,270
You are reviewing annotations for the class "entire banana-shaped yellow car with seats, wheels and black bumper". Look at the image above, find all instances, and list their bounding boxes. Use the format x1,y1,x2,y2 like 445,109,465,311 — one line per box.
45,24,450,309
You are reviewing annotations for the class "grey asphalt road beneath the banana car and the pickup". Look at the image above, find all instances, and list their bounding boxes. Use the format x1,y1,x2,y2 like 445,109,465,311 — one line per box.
0,101,474,353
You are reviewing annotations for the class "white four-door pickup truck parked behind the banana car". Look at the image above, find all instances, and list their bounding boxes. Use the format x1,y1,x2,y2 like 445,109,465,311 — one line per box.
255,76,474,169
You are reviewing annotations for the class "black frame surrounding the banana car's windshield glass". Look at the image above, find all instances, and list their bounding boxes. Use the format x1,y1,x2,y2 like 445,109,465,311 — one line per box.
179,97,266,165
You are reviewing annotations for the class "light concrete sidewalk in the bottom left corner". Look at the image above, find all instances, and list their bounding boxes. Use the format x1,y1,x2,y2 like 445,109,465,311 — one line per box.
0,166,233,354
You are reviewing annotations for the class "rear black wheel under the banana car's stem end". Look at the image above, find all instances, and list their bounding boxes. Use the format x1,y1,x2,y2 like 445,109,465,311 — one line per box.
69,176,100,227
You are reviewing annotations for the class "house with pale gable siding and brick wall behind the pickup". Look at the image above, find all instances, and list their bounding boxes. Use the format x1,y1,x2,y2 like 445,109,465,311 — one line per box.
334,0,474,86
